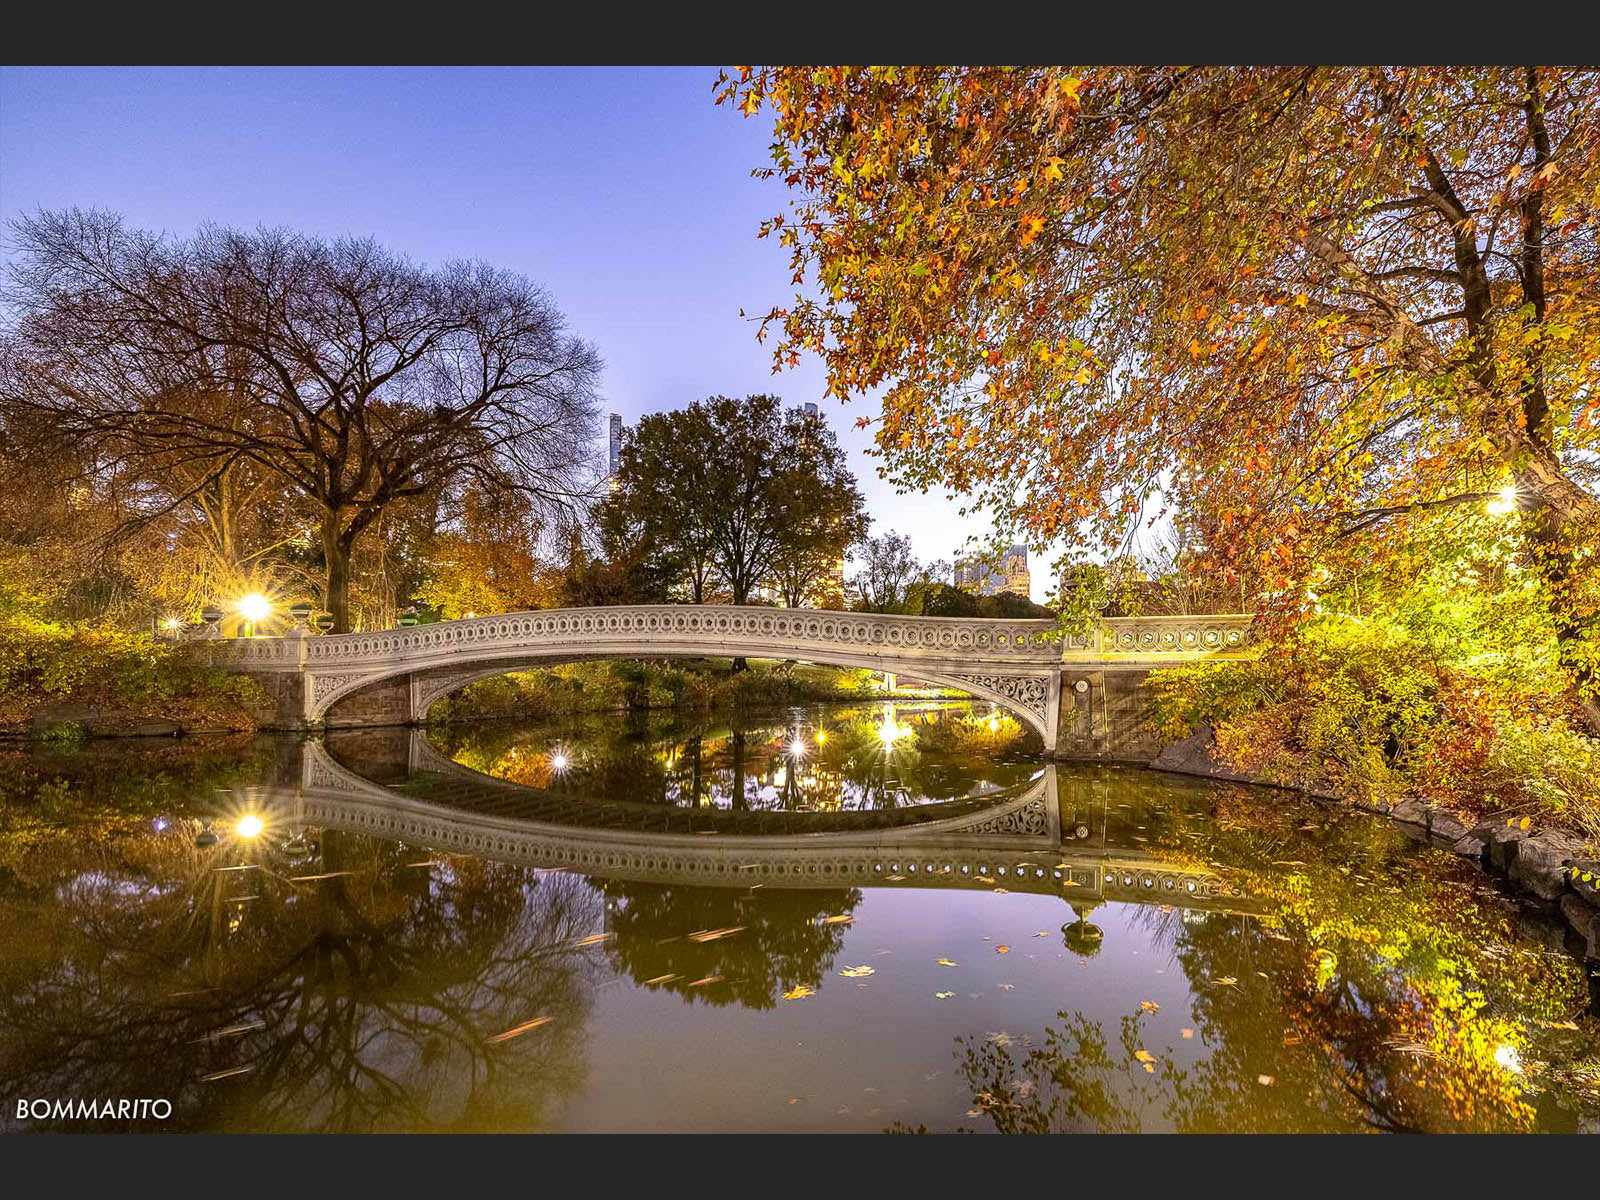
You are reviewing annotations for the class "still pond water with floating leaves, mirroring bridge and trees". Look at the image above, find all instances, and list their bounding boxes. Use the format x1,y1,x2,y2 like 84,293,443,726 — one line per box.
0,702,1600,1131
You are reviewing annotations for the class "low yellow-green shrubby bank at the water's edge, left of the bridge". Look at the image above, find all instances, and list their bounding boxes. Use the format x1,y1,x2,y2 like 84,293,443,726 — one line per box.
0,616,266,739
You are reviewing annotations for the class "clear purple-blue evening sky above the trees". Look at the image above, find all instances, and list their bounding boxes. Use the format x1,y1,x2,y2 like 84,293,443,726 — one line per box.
0,67,1048,600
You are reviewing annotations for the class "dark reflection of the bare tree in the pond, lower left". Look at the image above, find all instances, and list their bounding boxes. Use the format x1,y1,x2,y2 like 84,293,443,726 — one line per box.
0,802,600,1131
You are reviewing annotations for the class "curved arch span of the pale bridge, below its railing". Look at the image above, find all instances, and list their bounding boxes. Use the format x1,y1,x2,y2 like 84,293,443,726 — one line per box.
309,643,1059,749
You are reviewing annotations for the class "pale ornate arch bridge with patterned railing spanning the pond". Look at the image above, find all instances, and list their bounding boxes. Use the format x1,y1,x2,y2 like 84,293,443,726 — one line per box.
213,605,1251,758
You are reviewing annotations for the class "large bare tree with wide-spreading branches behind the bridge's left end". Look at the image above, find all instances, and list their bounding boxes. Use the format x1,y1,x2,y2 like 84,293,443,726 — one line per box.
0,210,600,630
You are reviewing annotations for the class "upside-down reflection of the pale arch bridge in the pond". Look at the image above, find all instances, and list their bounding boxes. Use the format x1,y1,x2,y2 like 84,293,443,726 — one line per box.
258,730,1267,914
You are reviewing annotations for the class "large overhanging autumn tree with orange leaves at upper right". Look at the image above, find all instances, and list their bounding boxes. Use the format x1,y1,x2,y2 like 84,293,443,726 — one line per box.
717,67,1600,728
